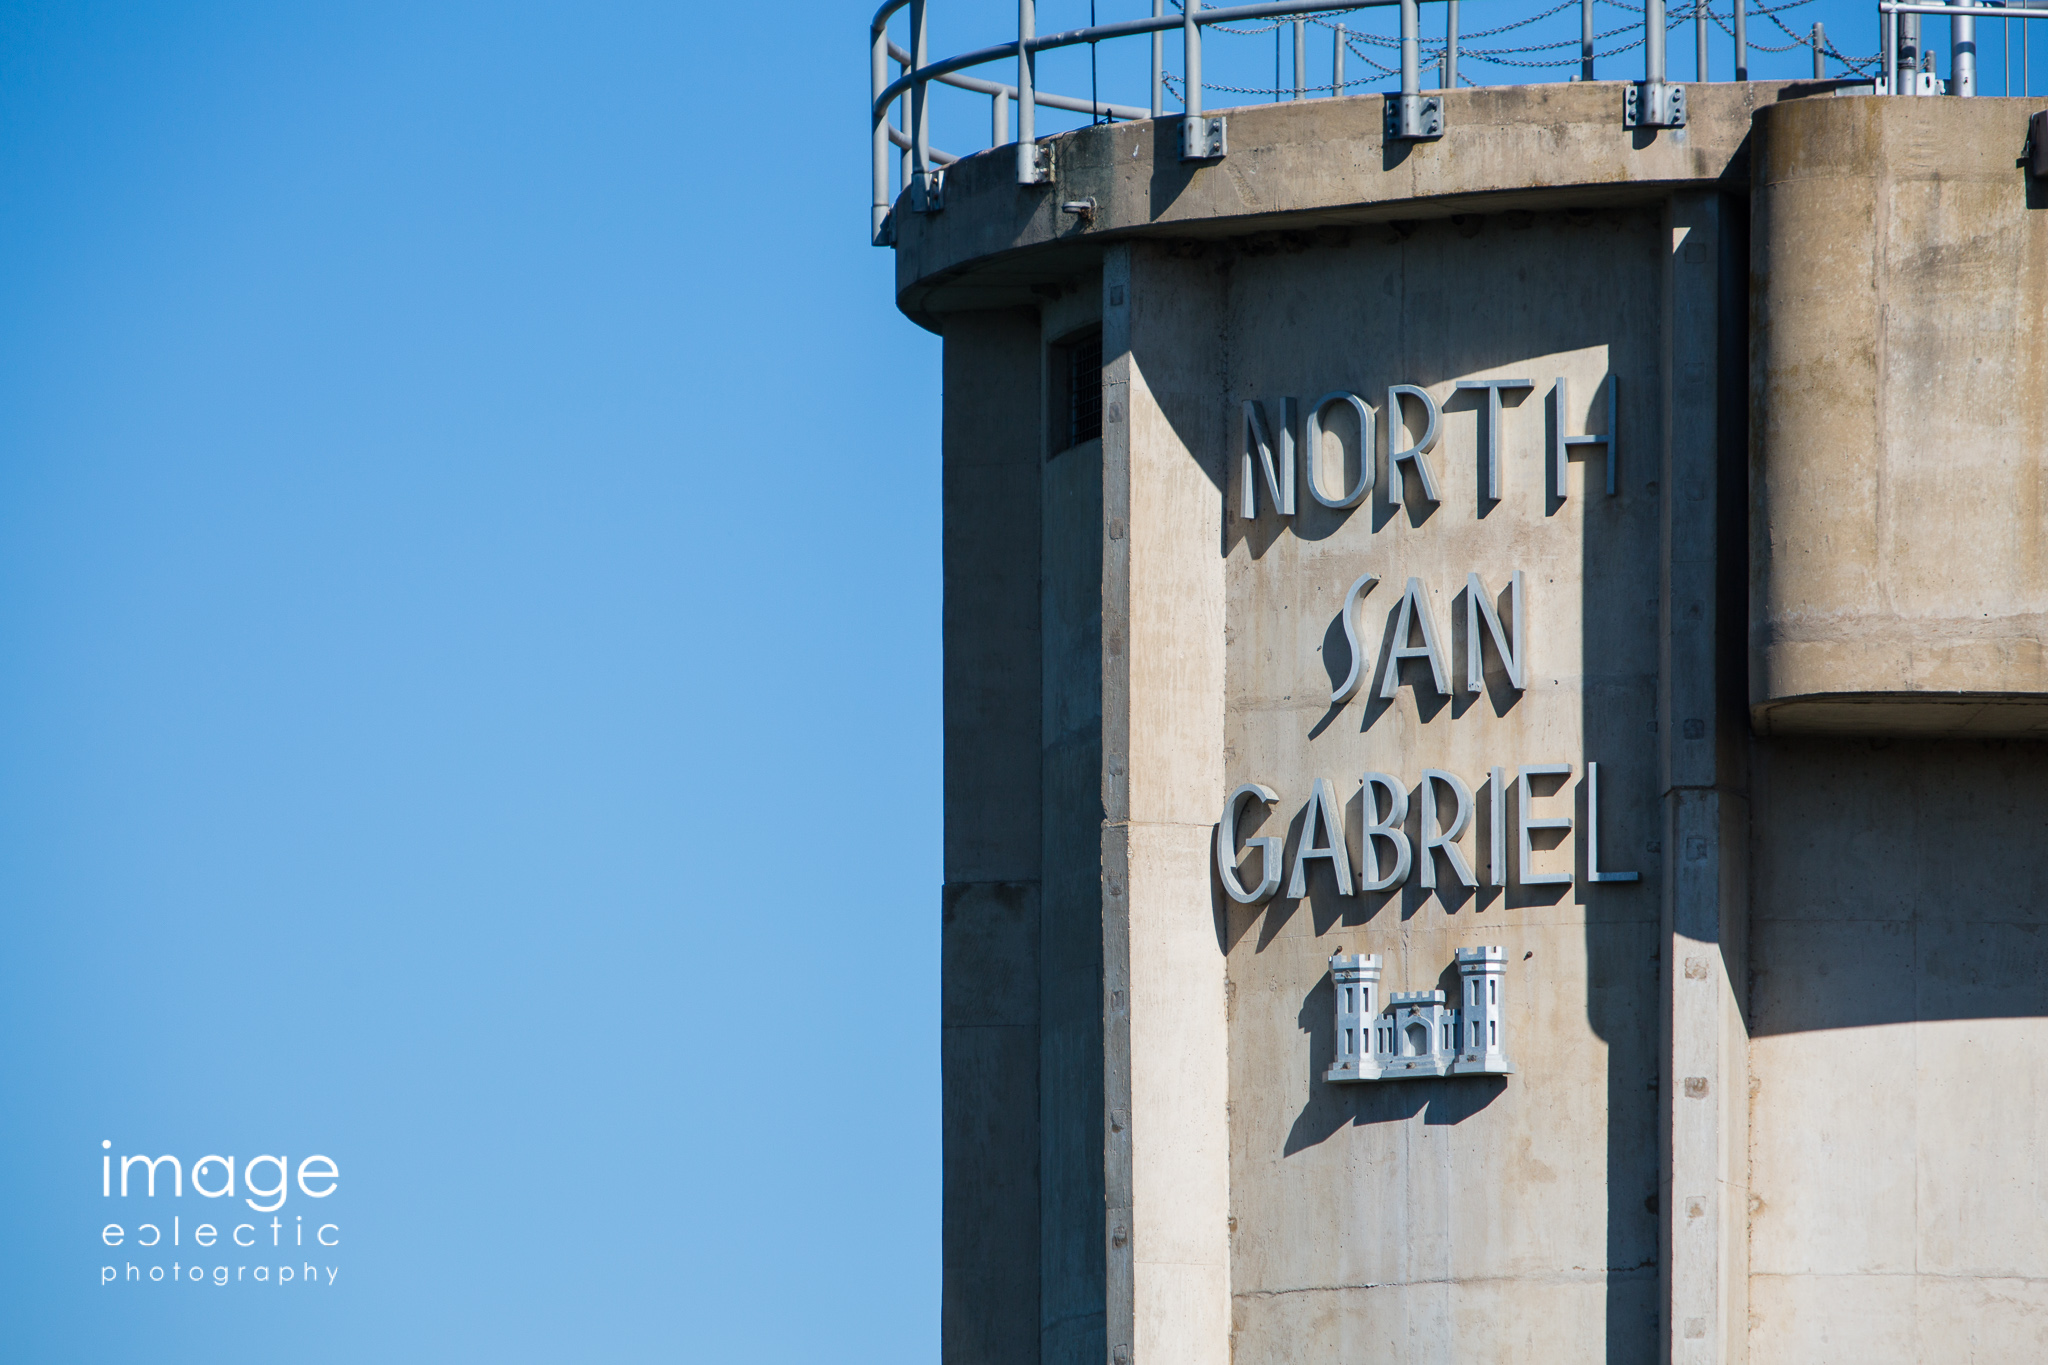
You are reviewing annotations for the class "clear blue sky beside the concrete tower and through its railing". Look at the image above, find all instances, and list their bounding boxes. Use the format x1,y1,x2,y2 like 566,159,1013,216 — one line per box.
0,0,2015,1365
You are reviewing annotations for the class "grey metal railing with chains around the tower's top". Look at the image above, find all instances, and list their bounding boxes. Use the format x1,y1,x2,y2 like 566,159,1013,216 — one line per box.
868,0,2048,246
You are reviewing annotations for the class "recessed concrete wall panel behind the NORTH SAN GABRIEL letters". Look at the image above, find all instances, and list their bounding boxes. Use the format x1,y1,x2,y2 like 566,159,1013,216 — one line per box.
1187,209,1679,1365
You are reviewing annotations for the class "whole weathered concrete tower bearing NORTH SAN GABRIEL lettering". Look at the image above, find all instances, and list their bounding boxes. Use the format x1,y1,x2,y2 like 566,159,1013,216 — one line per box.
913,84,2048,1365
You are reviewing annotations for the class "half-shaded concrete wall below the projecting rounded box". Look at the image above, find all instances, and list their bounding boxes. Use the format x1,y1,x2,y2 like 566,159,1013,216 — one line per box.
1749,739,2048,1365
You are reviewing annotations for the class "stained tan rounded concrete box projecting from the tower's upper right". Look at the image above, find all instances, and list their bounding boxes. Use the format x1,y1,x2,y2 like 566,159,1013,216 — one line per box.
1751,98,2048,735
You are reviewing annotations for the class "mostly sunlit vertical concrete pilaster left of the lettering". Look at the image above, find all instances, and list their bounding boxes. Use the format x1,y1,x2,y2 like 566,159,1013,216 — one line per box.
1102,248,1231,1365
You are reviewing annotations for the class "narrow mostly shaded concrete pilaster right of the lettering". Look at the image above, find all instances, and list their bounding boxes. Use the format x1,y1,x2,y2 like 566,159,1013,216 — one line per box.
1657,192,1749,1365
